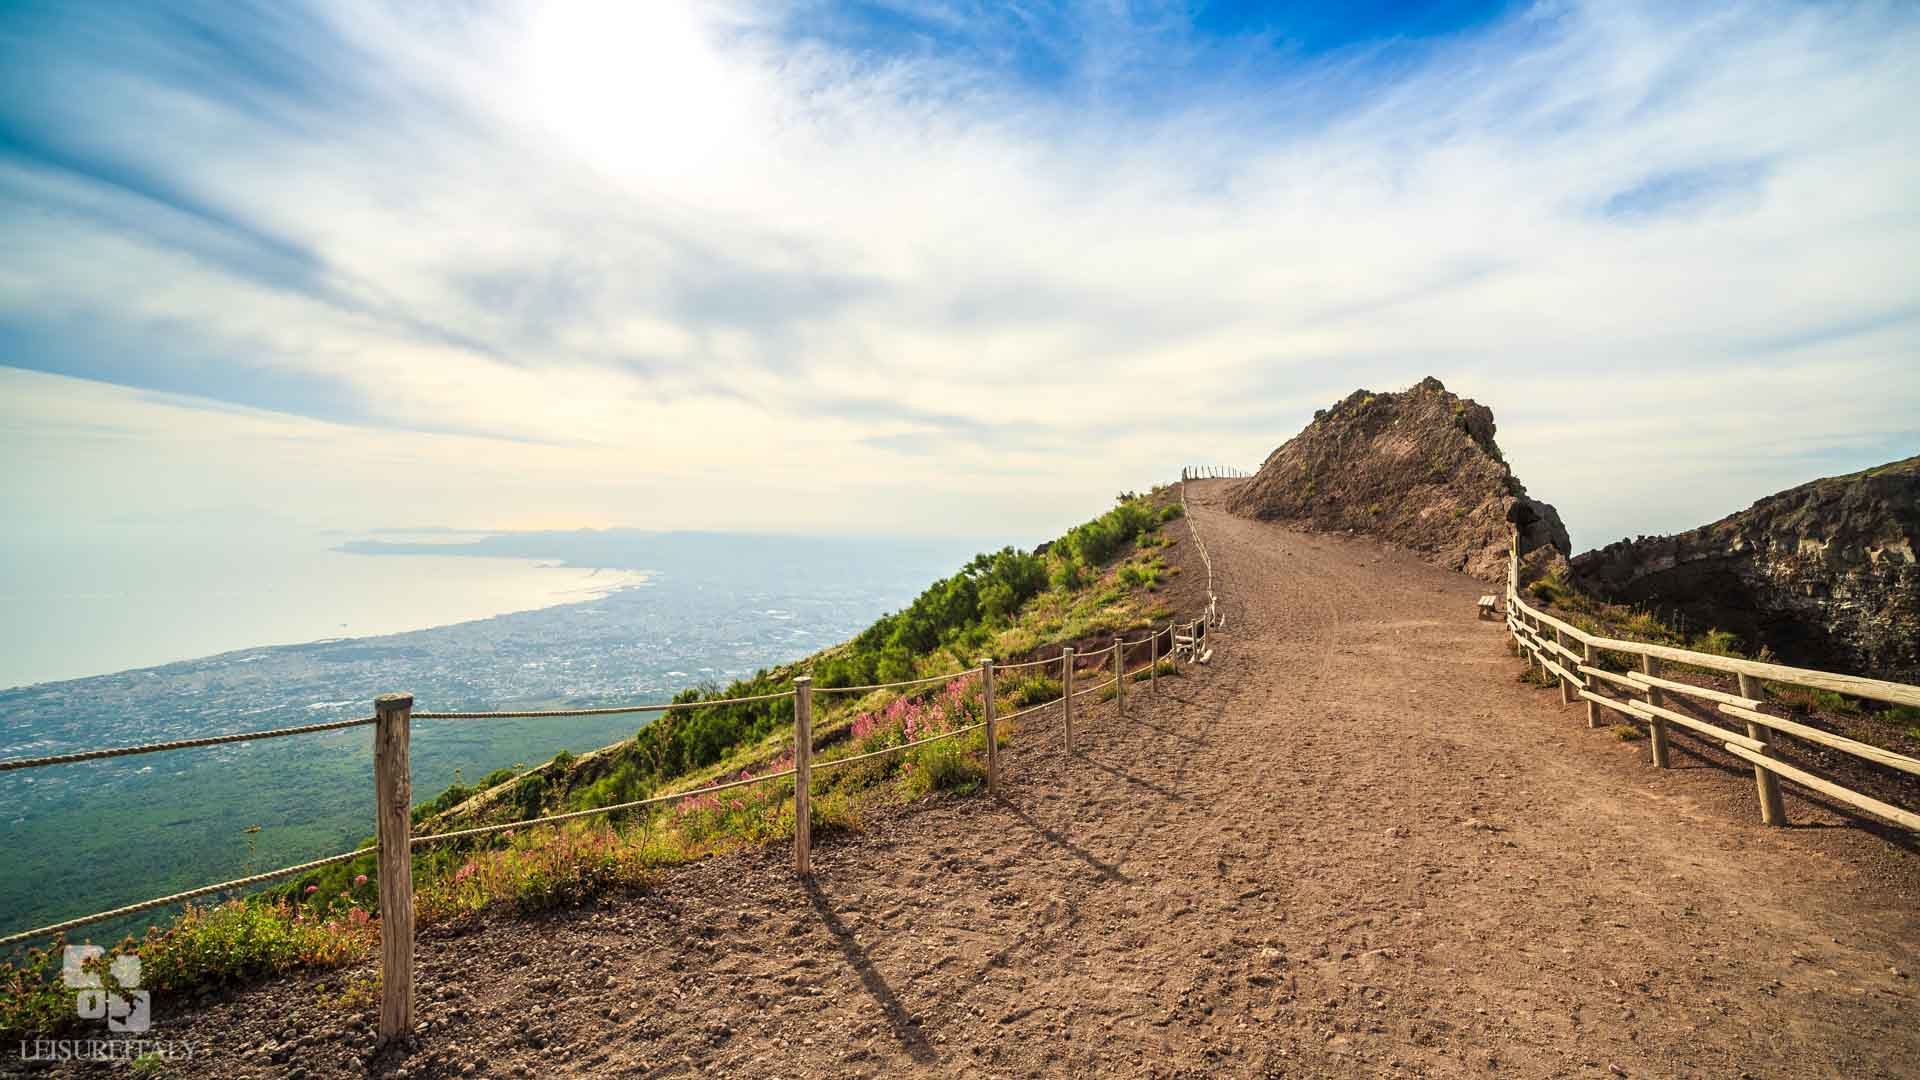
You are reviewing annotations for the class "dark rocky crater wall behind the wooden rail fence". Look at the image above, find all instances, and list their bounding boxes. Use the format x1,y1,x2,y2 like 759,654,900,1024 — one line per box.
1572,457,1920,682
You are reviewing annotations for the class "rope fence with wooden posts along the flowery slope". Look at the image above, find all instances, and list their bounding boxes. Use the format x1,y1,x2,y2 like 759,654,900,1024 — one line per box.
0,471,1225,1042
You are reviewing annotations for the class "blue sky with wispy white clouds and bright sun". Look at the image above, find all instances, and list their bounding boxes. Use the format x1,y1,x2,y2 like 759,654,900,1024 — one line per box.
0,0,1920,548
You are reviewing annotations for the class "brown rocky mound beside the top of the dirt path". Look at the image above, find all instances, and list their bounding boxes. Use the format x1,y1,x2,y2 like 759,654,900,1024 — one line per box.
1227,379,1569,582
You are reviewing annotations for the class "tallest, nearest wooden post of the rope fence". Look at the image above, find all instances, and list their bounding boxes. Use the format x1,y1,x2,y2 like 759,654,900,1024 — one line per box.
372,694,413,1043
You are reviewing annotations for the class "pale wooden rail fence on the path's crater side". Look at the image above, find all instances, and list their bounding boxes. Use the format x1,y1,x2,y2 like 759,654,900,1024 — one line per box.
1507,527,1920,832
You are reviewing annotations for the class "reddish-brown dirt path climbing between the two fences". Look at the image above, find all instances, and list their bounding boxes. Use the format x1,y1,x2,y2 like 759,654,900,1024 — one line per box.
22,482,1920,1078
